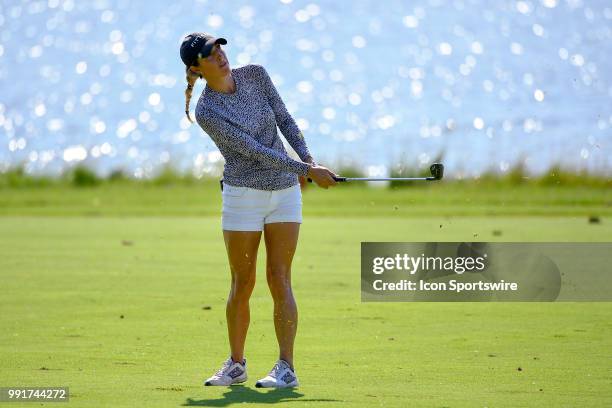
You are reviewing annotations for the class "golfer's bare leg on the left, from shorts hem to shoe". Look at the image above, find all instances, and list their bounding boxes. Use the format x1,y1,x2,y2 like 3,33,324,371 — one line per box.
223,230,261,361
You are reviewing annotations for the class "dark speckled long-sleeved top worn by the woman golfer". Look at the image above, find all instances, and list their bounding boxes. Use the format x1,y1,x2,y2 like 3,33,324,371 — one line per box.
195,64,312,190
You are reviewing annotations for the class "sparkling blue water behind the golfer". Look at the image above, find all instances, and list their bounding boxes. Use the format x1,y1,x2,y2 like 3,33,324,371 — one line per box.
0,0,612,178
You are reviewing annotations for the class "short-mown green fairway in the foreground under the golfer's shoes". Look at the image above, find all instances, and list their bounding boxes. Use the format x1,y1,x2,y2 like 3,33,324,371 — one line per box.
0,212,612,408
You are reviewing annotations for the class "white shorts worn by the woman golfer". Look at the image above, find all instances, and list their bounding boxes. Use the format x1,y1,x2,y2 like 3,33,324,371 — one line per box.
221,183,302,231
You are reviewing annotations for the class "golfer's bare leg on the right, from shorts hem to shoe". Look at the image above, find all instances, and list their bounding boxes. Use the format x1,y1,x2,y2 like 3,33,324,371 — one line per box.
264,222,300,367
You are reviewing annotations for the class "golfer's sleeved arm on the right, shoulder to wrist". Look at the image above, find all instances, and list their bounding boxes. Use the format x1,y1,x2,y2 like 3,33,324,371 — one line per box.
258,65,316,164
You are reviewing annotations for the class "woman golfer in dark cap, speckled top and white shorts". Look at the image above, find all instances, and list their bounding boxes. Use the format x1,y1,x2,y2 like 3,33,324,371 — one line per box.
180,33,336,387
